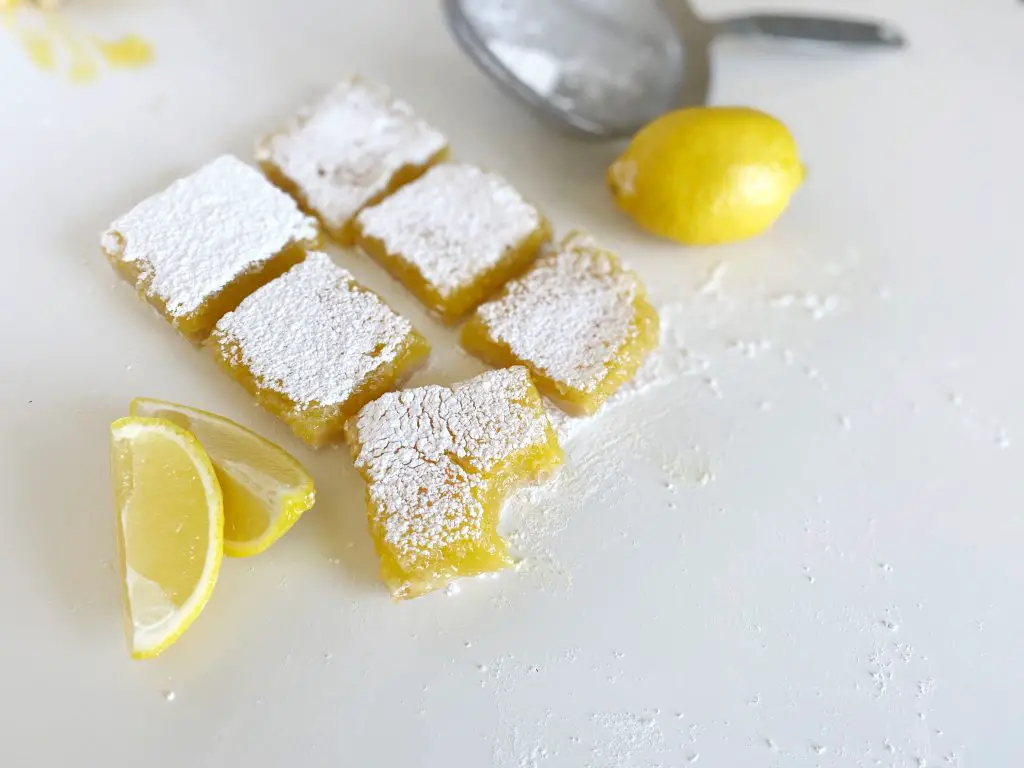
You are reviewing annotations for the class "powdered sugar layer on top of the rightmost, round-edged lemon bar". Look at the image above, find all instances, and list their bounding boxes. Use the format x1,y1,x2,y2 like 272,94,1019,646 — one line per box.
468,233,643,392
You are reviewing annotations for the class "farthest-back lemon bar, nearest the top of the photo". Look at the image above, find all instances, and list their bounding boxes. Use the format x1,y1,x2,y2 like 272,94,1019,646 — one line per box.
256,78,447,245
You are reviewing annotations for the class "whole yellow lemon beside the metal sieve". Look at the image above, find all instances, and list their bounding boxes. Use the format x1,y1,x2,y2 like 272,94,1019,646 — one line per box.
608,106,804,245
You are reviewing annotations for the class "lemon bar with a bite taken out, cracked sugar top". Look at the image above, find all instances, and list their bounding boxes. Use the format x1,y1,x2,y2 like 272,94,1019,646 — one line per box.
346,368,562,599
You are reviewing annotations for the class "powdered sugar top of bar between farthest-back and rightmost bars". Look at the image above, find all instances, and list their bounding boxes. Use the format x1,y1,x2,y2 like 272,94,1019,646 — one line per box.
357,164,543,297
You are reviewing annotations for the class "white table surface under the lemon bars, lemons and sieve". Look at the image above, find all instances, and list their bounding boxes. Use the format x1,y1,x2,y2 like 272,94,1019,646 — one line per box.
0,0,1024,768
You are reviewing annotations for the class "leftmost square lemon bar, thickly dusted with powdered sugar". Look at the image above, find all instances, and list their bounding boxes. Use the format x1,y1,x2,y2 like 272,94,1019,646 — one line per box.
101,155,317,342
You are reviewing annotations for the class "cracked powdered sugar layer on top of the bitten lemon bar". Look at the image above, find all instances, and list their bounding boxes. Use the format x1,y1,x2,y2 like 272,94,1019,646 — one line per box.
354,368,553,569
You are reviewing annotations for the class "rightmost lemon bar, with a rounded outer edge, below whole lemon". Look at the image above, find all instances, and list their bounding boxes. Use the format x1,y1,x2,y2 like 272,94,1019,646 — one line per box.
462,232,658,415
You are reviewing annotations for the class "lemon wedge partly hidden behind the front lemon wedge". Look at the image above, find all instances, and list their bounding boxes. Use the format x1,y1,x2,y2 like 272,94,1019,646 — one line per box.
131,397,316,557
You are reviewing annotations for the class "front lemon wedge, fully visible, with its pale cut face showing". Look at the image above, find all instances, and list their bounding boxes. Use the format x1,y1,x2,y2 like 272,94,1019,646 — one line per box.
111,417,224,658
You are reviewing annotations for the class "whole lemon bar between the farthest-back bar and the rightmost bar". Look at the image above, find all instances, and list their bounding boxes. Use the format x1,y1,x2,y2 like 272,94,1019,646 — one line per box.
355,165,551,323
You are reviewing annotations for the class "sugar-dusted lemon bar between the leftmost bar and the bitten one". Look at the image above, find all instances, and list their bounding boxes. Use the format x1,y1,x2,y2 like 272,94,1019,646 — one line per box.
210,252,430,447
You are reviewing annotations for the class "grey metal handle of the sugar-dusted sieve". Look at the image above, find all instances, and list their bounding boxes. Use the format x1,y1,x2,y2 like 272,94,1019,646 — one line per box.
716,13,906,48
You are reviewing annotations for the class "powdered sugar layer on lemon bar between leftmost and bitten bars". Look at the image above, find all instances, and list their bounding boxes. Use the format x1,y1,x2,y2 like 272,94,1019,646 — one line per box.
213,253,413,410
